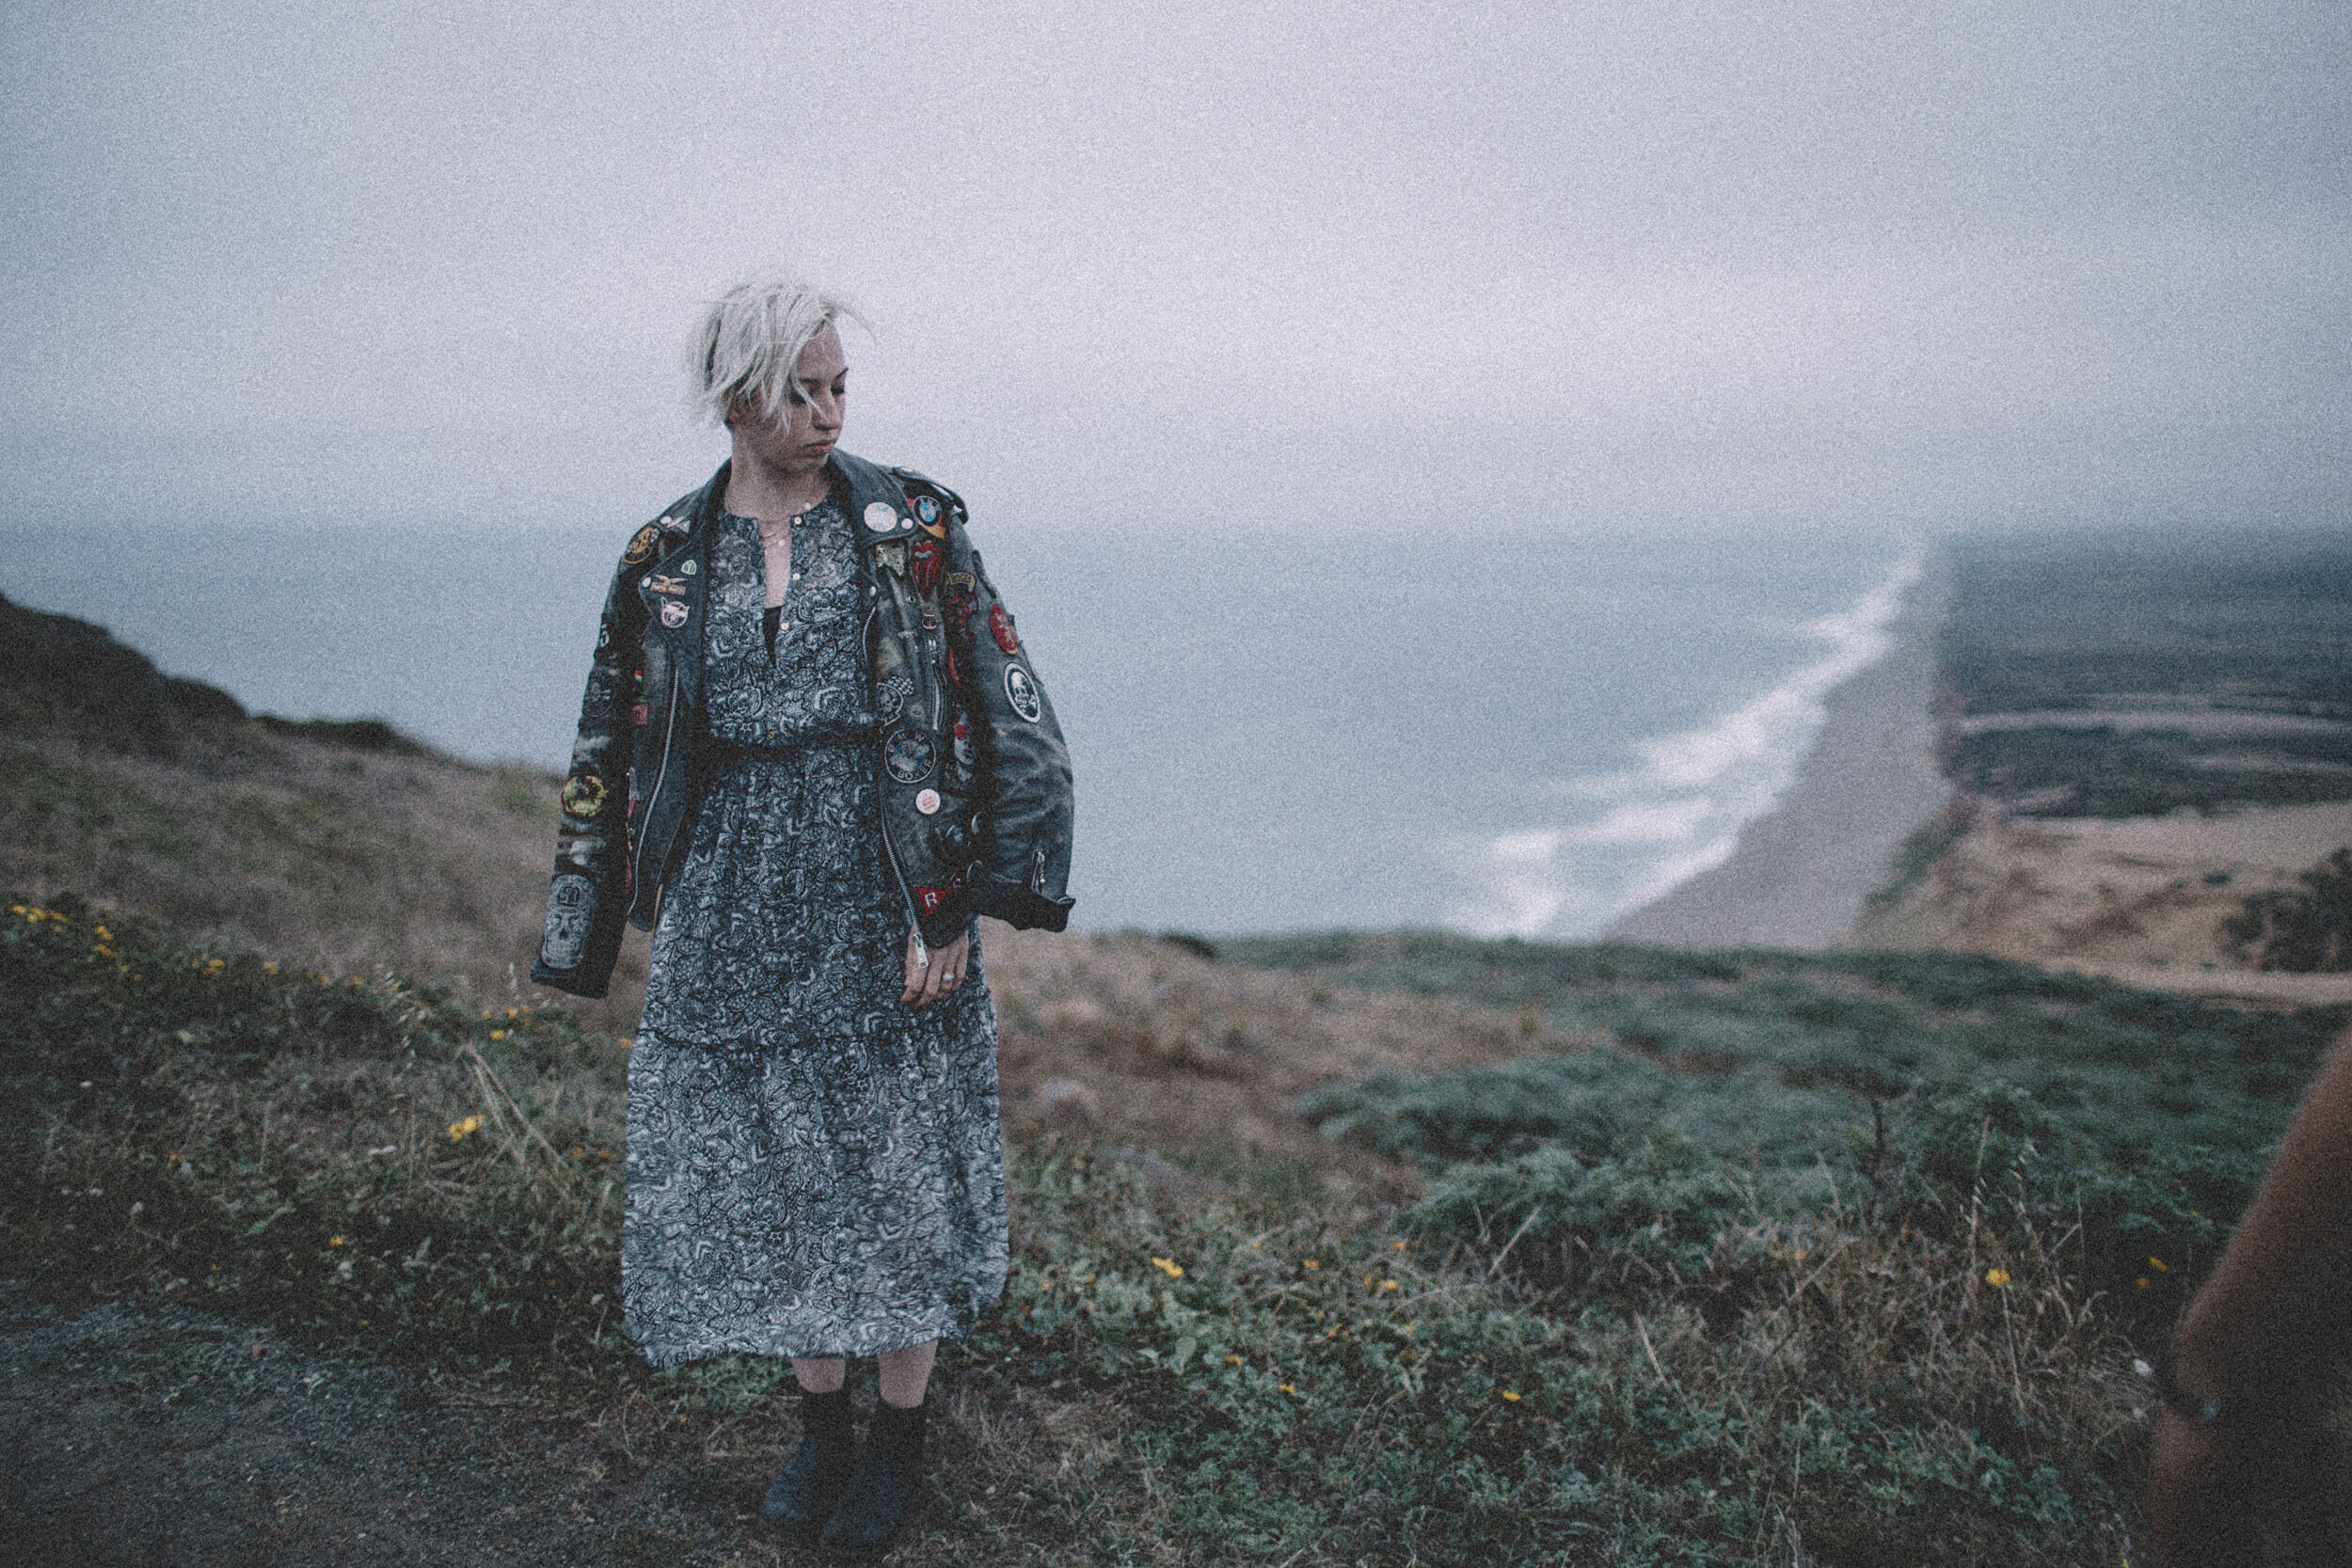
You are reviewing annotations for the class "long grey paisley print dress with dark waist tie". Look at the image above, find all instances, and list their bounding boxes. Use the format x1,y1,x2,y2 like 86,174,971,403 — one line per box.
621,500,1007,1366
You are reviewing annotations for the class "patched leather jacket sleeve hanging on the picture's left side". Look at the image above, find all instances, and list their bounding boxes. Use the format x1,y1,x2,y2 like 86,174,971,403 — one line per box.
532,527,654,997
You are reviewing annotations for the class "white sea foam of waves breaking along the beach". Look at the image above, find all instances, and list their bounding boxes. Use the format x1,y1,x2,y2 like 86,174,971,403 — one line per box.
1454,555,1922,936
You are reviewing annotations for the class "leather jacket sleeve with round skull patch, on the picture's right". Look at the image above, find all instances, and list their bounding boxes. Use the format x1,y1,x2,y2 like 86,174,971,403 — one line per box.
948,505,1077,931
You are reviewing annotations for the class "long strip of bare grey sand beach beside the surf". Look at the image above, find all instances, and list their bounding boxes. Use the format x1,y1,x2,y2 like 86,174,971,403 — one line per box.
1602,560,1952,950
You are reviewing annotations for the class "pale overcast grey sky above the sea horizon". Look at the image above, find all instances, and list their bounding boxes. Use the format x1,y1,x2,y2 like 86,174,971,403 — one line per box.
0,0,2352,527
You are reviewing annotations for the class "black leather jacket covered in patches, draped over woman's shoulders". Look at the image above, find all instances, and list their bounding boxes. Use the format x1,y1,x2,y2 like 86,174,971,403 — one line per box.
532,451,1075,997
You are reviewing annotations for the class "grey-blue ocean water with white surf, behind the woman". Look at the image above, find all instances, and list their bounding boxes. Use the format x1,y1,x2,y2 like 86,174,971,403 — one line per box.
0,524,1919,938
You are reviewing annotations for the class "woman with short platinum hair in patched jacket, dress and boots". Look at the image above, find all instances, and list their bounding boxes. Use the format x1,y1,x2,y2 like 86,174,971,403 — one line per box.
532,279,1071,1547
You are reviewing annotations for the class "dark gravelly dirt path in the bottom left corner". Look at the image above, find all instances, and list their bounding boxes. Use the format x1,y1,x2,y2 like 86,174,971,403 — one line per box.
0,1286,875,1568
